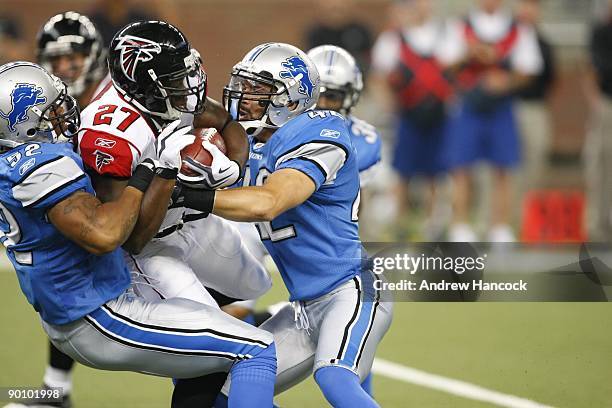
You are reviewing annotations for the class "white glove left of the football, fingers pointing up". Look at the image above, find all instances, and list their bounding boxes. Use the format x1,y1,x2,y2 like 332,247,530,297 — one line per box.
157,119,195,170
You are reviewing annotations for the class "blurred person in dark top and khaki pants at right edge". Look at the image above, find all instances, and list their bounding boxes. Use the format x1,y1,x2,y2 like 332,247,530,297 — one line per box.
584,1,612,242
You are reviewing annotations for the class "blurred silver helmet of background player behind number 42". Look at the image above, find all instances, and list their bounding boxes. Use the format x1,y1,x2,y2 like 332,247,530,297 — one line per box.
308,45,363,114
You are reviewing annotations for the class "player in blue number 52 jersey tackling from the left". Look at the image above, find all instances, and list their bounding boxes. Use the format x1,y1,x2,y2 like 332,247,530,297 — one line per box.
0,62,276,407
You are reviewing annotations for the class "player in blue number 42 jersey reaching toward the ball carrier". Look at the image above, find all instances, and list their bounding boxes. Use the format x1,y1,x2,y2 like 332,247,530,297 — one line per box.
172,43,391,407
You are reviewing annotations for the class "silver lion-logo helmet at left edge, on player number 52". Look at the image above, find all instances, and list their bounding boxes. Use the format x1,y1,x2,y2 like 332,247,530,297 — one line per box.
0,61,81,148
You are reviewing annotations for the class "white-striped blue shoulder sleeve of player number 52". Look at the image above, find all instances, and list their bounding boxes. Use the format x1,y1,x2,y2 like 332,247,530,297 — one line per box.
12,156,92,209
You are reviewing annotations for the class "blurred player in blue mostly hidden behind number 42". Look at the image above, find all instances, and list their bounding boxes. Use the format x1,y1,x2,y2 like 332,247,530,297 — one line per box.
308,45,382,187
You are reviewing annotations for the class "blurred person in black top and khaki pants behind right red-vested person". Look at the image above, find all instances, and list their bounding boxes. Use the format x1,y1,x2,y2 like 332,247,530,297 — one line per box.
516,0,555,202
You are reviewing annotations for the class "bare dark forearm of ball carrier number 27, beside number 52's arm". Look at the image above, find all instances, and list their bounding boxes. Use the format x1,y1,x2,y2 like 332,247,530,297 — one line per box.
123,177,175,254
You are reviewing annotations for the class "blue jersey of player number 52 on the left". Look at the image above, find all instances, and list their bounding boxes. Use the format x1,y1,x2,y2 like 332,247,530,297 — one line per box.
0,143,130,324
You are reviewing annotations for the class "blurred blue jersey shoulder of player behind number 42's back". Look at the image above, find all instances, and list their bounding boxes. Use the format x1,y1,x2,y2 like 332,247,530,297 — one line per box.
346,115,382,186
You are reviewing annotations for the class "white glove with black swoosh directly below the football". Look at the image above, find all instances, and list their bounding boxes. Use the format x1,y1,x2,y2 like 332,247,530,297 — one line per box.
178,140,240,190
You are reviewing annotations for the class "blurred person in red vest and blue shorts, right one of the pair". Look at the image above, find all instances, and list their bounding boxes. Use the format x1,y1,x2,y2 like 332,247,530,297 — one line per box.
440,0,543,242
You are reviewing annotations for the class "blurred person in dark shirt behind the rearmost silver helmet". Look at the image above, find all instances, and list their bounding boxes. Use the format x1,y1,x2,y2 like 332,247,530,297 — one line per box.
306,0,372,74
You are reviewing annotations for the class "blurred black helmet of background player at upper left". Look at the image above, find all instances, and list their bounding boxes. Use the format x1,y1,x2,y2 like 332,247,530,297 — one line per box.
36,11,106,98
